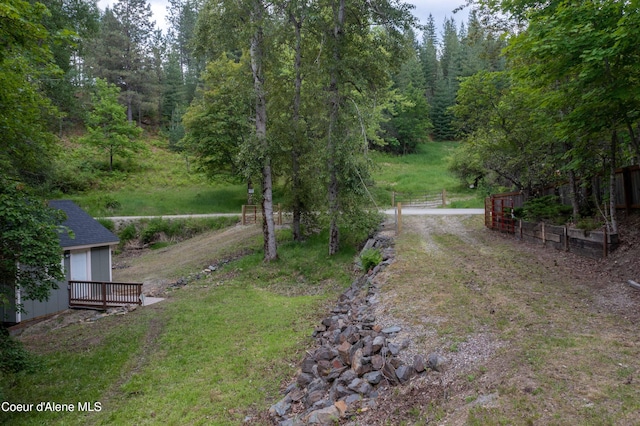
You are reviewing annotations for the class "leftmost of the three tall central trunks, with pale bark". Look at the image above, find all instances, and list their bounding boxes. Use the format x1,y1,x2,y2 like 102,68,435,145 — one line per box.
250,0,278,262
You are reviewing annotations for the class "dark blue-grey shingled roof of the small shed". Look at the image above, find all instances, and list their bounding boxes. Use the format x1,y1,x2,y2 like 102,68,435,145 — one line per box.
49,200,119,248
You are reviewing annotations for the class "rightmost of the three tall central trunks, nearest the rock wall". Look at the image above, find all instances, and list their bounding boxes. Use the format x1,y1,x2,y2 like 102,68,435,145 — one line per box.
327,0,345,255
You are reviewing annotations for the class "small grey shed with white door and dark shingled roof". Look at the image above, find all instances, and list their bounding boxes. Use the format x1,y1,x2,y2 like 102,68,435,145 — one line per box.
0,200,119,323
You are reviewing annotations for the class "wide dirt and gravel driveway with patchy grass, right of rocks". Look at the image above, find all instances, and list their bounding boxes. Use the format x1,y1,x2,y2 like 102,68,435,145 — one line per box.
352,216,640,425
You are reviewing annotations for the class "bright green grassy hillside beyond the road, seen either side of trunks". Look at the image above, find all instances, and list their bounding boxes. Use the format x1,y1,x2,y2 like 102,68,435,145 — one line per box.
71,140,481,216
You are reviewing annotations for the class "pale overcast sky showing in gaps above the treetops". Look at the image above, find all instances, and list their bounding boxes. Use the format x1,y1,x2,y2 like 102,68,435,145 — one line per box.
98,0,468,36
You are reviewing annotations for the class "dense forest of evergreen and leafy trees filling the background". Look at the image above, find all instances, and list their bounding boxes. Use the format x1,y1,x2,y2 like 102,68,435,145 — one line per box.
0,0,640,280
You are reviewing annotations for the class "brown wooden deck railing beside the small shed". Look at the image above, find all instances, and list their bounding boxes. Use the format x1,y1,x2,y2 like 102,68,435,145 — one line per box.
69,281,142,309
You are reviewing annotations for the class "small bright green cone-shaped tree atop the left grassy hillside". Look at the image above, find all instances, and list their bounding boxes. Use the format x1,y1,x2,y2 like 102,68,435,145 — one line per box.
80,79,144,170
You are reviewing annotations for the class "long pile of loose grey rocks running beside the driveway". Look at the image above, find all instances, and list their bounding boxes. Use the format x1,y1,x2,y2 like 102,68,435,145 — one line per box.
269,236,444,426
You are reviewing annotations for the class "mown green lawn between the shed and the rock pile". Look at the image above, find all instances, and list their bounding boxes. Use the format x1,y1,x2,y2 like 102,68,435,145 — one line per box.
0,233,355,425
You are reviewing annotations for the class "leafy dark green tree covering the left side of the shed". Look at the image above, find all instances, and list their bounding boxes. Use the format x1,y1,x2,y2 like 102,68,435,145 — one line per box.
0,180,64,309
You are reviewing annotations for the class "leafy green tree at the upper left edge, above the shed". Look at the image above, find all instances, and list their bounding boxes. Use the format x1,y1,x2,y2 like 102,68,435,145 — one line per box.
0,0,60,185
